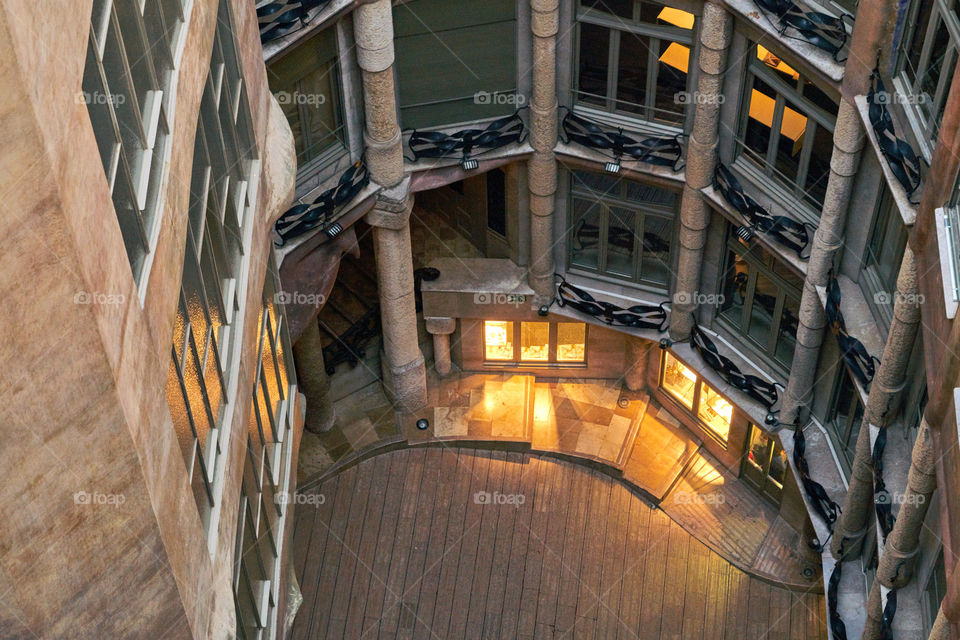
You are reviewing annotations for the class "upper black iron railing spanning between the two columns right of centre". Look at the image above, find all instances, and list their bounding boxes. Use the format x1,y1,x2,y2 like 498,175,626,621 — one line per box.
560,107,683,171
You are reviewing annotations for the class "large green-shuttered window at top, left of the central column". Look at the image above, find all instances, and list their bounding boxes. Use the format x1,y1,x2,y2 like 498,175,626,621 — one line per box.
393,0,523,129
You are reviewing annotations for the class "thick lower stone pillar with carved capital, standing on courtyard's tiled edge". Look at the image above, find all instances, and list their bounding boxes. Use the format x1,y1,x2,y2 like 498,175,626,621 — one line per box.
365,178,427,412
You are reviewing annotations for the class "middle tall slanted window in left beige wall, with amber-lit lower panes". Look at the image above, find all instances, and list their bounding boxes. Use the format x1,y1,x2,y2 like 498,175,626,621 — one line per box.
167,0,256,526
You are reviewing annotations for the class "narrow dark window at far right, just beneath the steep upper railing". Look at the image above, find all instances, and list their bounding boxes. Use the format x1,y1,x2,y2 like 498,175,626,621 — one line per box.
863,185,907,326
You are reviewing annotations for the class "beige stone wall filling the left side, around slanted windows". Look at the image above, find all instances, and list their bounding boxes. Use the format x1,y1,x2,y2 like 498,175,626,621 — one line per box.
0,0,293,638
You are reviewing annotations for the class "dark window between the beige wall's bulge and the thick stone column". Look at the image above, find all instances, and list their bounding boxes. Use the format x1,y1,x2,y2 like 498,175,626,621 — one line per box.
267,27,346,169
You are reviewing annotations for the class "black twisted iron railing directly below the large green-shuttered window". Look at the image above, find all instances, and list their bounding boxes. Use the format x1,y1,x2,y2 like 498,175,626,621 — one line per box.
407,109,527,170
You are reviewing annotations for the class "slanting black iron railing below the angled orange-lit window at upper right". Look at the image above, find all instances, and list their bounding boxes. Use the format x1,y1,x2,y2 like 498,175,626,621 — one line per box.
713,162,814,260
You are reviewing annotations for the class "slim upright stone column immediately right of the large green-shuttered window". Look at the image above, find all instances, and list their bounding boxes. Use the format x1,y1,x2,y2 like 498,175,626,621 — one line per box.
527,0,560,298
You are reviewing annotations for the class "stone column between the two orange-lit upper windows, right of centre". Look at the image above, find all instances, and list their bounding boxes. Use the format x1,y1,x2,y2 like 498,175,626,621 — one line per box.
670,1,733,340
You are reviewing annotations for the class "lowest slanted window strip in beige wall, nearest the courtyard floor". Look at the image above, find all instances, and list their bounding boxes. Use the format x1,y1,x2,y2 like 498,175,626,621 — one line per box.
233,254,296,639
